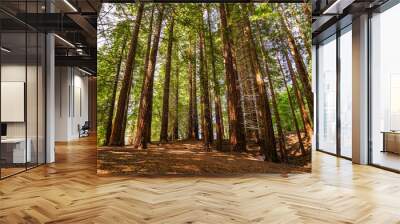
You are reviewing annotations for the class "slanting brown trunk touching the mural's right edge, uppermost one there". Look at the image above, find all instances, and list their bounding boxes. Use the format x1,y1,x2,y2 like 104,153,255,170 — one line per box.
279,13,314,116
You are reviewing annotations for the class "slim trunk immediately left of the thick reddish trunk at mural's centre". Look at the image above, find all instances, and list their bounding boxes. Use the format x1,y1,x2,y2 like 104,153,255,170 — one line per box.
207,5,224,150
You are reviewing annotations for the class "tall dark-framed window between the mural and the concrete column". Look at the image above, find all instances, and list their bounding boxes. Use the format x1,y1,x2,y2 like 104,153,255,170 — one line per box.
316,25,352,159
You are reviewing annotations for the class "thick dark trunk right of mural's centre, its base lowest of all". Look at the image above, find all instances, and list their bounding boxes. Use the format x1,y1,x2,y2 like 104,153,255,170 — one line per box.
242,4,279,162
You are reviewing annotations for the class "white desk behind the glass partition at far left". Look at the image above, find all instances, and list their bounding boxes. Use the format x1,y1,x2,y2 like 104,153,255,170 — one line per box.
1,138,32,163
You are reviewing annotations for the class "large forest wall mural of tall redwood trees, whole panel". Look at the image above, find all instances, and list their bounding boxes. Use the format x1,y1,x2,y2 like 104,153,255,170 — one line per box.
97,3,313,175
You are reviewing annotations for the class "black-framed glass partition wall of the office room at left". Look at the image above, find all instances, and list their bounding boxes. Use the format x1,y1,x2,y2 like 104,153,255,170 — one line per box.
0,1,46,179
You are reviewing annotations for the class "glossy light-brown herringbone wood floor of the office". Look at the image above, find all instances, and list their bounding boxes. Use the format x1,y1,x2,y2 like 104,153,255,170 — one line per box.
0,136,400,224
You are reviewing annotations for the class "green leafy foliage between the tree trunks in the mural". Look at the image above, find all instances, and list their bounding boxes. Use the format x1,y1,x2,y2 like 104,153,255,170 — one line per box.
97,3,311,145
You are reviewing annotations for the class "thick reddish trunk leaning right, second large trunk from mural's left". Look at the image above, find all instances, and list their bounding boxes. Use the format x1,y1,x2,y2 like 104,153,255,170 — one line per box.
133,5,164,148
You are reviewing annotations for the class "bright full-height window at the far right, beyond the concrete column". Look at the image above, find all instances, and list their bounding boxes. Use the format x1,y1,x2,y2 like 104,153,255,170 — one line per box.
370,4,400,171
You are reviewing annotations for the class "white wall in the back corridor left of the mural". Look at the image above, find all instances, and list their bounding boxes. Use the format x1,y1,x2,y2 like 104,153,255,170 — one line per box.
55,67,88,141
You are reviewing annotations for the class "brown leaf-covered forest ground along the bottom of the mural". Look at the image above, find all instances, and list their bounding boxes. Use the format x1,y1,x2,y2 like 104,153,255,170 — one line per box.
97,134,311,176
